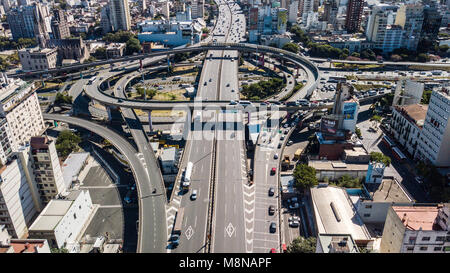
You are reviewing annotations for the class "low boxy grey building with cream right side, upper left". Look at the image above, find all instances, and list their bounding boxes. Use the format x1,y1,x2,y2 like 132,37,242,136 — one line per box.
19,48,58,71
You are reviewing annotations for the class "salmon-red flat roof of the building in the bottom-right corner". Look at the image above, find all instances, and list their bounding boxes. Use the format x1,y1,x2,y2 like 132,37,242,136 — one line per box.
392,206,441,230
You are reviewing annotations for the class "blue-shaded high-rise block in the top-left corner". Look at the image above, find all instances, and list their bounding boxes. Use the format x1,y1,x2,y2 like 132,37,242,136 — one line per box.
6,3,49,45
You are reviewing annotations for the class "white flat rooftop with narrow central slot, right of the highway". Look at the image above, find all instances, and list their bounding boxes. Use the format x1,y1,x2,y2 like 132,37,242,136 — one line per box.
311,186,371,241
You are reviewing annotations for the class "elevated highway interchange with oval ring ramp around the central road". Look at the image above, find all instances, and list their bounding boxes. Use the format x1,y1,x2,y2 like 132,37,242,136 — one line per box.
36,0,450,253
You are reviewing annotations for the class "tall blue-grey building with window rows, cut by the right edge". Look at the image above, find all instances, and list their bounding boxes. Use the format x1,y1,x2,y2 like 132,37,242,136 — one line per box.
416,88,450,167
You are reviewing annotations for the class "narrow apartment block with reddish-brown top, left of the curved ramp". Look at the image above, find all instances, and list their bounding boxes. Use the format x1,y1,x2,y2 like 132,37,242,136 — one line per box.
30,137,67,204
